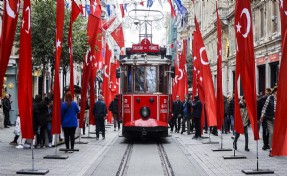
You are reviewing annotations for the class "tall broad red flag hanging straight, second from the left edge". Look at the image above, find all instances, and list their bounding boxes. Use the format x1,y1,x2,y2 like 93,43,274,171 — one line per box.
18,0,34,139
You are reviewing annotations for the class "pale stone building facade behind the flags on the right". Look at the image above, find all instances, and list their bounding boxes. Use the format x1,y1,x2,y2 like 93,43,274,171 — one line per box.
189,0,281,95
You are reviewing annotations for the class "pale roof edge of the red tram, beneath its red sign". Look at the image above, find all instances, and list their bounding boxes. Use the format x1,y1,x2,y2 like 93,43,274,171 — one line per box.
120,54,172,65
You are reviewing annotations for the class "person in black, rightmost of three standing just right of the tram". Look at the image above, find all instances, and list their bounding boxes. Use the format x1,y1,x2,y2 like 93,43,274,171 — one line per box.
191,96,202,139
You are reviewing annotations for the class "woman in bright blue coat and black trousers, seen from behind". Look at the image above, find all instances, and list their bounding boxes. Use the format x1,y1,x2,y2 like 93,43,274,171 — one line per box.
61,92,79,153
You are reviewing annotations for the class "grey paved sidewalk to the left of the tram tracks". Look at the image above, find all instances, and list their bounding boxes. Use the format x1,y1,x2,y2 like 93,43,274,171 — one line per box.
0,124,120,176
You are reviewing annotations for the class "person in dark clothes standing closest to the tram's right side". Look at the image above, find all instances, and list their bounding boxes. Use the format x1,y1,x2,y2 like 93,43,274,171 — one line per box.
170,95,182,133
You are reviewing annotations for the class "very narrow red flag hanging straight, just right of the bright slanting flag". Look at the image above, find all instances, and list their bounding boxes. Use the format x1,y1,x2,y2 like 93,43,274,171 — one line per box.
216,2,224,130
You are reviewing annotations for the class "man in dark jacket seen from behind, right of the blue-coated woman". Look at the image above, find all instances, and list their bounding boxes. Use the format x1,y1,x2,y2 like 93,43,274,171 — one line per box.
93,95,107,140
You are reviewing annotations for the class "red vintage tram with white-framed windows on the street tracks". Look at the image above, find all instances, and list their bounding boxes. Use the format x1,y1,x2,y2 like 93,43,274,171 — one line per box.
117,38,174,138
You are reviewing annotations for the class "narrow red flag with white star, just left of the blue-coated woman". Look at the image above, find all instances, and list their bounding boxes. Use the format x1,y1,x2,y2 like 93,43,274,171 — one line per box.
52,0,65,134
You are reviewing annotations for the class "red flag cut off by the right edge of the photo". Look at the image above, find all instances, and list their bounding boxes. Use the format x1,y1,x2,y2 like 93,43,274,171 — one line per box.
272,0,287,156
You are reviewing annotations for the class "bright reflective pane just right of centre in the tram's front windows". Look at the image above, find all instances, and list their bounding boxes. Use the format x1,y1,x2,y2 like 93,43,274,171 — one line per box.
146,66,157,92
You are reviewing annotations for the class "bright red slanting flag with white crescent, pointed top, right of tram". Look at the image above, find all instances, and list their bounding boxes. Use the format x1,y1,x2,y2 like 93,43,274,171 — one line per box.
194,17,217,126
